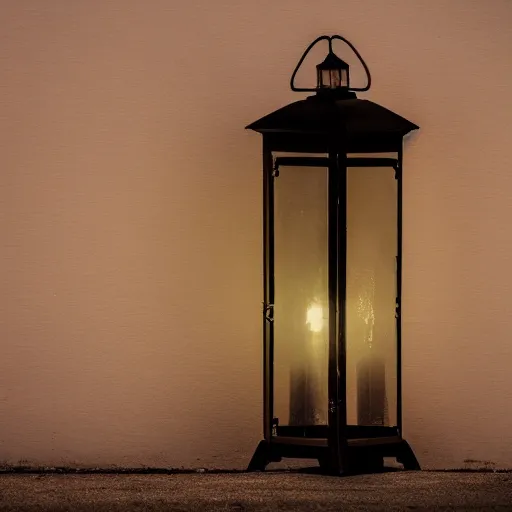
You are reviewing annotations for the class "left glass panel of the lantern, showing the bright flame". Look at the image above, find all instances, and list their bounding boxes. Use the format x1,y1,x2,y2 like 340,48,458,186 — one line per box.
273,166,329,426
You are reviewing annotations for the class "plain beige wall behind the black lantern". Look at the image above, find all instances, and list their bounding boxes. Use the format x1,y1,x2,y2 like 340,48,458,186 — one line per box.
0,0,512,468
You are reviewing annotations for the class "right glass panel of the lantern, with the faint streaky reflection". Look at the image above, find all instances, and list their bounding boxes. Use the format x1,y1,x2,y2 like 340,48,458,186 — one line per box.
346,167,398,426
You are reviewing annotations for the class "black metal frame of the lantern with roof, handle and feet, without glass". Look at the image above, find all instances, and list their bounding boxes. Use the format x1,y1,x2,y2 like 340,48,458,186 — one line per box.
247,36,420,474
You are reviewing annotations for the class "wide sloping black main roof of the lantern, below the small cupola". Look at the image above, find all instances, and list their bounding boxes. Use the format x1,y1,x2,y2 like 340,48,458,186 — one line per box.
246,91,419,140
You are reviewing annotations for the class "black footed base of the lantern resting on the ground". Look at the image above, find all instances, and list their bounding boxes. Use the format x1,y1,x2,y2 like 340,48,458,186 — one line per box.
247,436,421,475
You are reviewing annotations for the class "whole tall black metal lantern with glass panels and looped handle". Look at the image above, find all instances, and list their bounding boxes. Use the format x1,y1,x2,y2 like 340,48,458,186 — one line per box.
247,35,419,474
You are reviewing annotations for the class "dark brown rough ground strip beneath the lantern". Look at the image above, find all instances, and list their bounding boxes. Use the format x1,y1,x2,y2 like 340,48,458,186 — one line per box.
0,471,512,512
